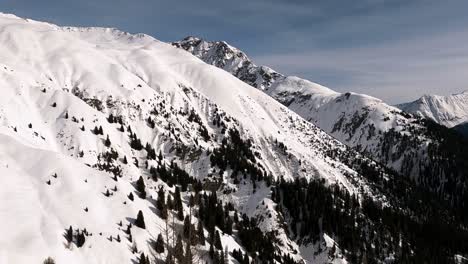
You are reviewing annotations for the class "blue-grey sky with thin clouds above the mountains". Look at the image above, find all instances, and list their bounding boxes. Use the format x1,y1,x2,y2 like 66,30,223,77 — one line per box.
0,0,468,103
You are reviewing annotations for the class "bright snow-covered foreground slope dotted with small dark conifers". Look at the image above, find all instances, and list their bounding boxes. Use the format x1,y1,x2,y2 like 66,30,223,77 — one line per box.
0,14,384,263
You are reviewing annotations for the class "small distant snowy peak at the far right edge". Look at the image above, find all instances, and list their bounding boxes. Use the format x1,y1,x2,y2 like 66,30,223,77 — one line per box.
397,91,468,127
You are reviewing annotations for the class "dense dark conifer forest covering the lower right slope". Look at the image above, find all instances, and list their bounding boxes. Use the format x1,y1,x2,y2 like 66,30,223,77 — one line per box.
272,176,468,263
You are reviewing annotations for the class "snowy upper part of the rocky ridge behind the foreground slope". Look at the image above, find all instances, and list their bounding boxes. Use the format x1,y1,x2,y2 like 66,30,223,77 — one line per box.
172,37,426,172
